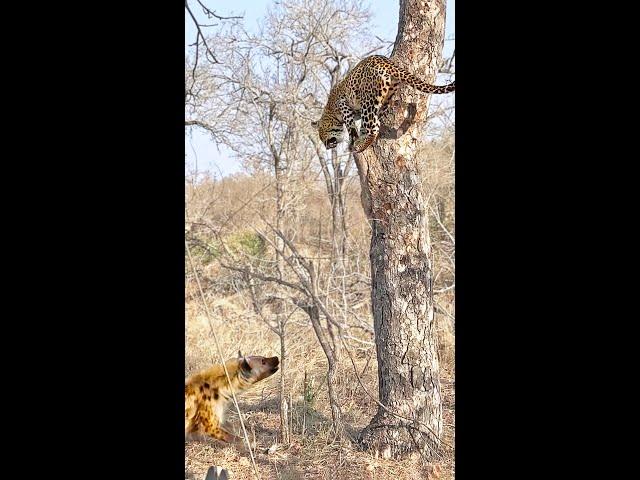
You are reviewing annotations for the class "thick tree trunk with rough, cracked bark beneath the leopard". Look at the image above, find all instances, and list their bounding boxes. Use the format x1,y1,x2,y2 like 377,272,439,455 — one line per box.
355,0,445,460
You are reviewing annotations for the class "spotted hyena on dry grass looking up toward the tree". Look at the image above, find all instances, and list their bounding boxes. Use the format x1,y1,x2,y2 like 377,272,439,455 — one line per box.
184,354,280,442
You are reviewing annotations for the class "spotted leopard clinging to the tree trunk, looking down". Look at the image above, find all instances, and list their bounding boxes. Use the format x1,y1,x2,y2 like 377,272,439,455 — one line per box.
311,55,456,153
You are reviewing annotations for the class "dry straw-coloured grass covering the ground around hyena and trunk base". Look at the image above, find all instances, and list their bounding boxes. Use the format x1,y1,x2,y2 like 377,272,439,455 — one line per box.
185,295,455,480
